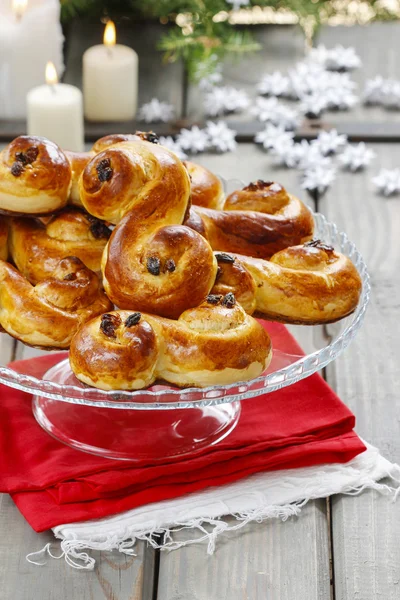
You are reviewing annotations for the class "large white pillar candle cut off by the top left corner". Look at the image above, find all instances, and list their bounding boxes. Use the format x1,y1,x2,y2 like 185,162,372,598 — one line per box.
0,0,63,119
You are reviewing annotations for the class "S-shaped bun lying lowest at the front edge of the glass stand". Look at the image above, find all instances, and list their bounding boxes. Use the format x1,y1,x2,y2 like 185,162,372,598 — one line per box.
70,294,272,390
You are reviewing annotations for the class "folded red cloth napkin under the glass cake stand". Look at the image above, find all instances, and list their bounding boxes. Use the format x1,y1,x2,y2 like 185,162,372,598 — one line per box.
0,323,365,531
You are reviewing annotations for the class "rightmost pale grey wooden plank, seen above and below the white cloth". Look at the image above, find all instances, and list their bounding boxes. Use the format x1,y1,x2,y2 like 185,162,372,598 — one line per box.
323,145,400,600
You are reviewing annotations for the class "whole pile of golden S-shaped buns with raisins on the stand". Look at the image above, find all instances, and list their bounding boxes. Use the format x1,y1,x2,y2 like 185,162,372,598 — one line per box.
0,132,361,390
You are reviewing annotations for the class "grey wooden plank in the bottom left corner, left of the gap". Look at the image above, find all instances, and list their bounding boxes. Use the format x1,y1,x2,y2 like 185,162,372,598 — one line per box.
0,495,153,600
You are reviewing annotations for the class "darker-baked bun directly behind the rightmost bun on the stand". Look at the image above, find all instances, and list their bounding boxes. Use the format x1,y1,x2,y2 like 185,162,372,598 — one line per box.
185,182,314,259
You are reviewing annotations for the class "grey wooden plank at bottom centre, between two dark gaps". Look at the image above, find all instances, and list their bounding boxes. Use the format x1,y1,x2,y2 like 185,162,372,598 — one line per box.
157,500,330,600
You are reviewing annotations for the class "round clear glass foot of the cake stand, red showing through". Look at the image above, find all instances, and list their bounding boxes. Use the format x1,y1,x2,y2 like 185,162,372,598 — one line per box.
33,396,240,464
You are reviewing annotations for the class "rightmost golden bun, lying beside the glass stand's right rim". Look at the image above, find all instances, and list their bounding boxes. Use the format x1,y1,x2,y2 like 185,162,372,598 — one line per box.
213,240,362,325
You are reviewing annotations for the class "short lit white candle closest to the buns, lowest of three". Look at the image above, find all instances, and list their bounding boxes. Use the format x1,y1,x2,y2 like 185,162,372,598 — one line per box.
27,62,84,152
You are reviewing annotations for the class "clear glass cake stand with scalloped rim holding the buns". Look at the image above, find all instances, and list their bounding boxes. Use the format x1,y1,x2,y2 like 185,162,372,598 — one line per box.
0,213,370,464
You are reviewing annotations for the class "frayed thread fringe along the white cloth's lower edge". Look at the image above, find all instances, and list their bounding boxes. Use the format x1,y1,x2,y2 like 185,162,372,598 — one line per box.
26,446,400,570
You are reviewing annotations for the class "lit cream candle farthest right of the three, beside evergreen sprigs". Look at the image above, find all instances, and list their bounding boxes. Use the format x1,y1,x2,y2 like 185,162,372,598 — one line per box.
83,21,138,121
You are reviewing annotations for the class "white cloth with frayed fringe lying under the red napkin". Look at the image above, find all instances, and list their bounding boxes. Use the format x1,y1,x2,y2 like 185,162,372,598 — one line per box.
27,444,400,570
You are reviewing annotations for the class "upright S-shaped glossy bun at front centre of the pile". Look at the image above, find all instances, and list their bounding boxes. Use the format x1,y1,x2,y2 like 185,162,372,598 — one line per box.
87,141,217,318
